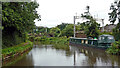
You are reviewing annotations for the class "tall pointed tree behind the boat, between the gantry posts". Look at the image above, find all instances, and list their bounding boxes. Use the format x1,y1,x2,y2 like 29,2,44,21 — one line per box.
81,6,100,38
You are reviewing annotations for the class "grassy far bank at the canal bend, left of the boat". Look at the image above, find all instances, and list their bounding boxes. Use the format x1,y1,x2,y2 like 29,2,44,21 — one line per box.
35,36,69,50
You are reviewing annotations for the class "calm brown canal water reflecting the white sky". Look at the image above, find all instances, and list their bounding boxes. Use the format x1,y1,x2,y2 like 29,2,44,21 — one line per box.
3,45,120,66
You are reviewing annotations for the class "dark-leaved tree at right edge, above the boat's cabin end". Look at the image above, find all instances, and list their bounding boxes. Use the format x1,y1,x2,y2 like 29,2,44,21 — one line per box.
108,0,120,40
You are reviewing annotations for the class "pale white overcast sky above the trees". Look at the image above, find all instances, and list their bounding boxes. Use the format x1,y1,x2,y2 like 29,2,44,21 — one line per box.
35,0,114,28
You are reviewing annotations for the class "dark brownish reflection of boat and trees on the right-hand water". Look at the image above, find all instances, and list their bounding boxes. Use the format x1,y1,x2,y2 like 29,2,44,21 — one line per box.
71,46,119,66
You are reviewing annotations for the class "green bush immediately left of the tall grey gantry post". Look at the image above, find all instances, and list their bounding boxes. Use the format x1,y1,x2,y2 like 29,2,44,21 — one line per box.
61,24,73,37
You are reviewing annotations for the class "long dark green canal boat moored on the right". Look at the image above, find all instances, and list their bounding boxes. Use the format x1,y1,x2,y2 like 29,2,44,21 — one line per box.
69,35,115,49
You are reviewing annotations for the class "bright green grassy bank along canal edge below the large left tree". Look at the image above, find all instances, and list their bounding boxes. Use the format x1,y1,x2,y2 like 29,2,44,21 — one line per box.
2,41,33,61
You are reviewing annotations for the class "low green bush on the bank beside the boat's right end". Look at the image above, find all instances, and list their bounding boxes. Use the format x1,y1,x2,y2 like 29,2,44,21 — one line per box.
106,41,120,55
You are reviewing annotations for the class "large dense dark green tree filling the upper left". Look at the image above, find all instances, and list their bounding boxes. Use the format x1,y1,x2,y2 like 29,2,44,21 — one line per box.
2,2,40,46
